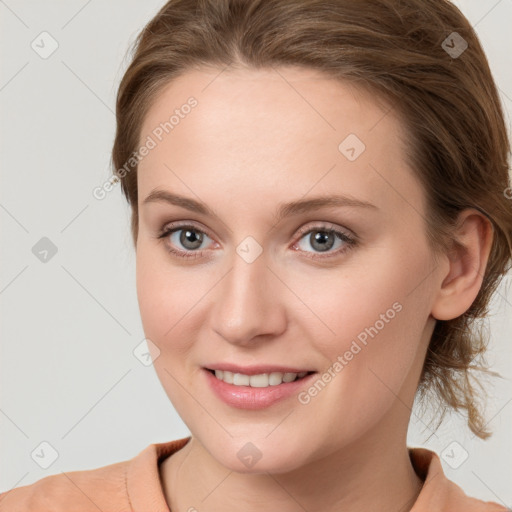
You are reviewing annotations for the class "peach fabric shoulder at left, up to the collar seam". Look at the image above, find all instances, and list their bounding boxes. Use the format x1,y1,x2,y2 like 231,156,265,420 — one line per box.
0,461,131,512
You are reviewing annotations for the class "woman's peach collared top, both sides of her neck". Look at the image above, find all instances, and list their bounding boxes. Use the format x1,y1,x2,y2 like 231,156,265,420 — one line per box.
0,437,510,512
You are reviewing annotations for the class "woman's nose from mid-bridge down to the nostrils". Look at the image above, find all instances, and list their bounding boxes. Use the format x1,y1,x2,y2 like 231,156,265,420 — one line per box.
211,250,290,345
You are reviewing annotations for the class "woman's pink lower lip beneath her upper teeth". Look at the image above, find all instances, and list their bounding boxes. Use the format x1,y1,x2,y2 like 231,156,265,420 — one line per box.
203,368,316,409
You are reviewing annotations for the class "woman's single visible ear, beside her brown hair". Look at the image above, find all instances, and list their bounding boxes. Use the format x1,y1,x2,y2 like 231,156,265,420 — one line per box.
431,208,493,320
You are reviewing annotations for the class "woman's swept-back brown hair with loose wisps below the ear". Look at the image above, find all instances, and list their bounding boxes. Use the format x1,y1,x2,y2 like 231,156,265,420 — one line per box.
112,0,512,439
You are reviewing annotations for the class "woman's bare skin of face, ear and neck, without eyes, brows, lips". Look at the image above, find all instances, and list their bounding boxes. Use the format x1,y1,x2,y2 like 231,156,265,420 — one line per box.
136,67,492,512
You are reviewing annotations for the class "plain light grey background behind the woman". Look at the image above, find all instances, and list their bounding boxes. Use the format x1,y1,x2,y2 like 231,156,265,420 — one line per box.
0,0,512,507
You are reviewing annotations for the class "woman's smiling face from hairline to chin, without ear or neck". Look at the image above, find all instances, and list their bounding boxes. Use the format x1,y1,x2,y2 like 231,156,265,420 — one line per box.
136,68,436,472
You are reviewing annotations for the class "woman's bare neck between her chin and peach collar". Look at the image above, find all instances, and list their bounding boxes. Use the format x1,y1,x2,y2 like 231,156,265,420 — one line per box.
161,400,423,512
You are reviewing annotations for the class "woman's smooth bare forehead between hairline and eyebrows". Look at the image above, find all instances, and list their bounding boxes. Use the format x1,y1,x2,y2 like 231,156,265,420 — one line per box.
138,67,421,217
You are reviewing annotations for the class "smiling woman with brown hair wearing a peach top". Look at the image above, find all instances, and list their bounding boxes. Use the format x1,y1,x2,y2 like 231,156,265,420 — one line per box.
0,0,512,512
